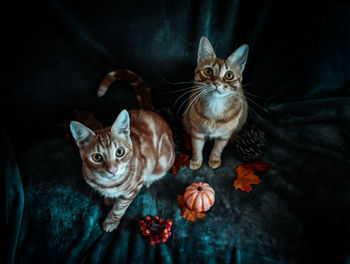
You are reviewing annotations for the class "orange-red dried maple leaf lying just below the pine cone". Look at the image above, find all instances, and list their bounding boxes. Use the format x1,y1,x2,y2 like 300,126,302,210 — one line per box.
234,162,271,193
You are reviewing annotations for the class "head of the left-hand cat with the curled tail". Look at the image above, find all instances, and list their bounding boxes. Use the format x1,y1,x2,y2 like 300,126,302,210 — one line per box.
70,110,132,183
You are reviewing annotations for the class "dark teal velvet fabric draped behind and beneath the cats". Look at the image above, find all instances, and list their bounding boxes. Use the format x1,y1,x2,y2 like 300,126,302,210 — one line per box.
0,0,350,263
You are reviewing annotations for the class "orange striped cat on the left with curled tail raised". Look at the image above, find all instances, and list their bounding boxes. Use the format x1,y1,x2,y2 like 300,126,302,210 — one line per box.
70,70,175,232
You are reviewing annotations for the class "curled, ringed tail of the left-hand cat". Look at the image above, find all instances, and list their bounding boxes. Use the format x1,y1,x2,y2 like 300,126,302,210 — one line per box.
97,69,154,111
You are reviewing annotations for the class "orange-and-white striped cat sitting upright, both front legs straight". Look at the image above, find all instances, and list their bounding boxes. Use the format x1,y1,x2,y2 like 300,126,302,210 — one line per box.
183,36,248,170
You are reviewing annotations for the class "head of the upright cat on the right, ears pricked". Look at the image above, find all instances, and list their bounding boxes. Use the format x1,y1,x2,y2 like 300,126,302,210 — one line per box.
194,36,249,98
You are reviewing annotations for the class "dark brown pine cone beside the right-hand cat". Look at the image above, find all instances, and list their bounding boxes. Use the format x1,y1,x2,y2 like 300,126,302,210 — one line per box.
233,127,265,162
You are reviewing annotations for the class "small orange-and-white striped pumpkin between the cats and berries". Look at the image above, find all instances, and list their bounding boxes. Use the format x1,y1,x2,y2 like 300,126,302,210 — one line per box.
183,182,215,212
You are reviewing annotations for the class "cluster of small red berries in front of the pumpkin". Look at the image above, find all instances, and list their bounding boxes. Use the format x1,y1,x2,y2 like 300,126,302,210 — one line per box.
139,216,173,246
